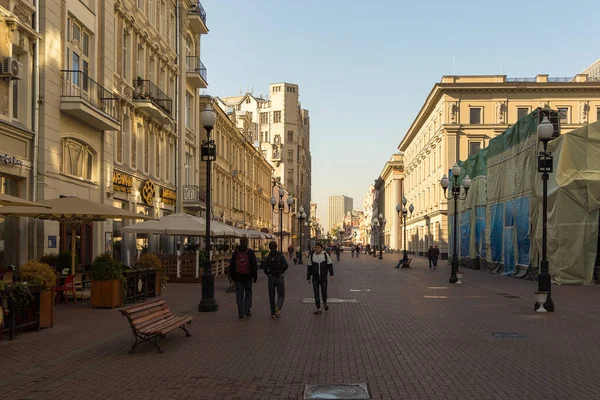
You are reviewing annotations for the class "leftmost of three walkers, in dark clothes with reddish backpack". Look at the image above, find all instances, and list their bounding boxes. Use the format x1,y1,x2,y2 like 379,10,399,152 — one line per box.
229,238,258,318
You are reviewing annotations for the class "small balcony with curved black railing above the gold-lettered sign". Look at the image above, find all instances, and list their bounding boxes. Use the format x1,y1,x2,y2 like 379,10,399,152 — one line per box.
133,79,173,123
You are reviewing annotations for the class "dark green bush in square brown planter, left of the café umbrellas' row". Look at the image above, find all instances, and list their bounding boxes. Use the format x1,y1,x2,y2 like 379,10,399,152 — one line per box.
90,253,123,308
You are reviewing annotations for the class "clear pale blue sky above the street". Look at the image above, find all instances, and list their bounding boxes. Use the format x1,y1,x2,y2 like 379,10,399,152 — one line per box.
202,0,600,230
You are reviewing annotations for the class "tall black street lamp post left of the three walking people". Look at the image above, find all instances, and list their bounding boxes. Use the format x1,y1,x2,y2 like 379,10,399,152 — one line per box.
198,103,219,312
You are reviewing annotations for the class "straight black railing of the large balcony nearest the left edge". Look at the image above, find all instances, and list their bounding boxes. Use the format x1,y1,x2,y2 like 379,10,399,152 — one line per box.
60,70,119,121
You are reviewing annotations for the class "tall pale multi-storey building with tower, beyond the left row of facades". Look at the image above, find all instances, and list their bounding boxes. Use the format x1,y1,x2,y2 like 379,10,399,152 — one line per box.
220,82,312,238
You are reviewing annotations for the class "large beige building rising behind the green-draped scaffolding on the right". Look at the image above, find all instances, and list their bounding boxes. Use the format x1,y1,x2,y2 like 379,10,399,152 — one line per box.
398,74,600,258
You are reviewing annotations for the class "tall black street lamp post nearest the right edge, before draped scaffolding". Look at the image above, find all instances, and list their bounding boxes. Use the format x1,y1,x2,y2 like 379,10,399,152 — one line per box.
534,116,554,312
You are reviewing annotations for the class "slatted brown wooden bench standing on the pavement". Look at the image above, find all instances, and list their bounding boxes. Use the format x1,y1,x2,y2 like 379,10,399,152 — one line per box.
120,299,192,353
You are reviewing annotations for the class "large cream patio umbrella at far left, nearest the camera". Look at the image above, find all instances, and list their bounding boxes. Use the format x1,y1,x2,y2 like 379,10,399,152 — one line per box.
0,196,157,274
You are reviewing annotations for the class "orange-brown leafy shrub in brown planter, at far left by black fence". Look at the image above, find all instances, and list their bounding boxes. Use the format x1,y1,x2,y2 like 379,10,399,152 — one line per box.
19,260,56,328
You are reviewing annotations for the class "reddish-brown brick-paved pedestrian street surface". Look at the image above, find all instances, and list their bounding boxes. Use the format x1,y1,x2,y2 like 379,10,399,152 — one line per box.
0,254,600,400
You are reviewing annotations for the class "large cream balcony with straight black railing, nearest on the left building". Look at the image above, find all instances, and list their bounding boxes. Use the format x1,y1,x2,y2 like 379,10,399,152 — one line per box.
60,70,121,131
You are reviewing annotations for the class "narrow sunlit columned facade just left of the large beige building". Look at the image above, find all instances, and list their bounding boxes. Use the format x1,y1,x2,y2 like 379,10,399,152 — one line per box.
375,153,404,250
